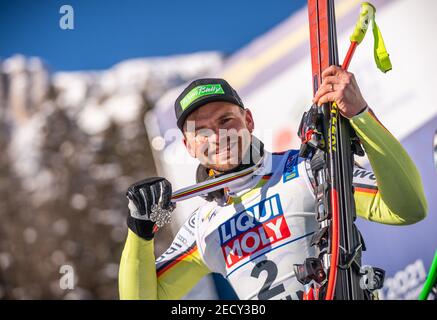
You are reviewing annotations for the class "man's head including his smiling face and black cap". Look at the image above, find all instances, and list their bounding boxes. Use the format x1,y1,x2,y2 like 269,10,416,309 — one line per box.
179,79,254,173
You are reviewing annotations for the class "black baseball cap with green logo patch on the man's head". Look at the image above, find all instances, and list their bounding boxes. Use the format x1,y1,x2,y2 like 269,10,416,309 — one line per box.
175,78,244,130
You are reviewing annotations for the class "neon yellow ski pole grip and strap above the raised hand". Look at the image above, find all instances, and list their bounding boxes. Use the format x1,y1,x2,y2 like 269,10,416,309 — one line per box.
350,2,392,73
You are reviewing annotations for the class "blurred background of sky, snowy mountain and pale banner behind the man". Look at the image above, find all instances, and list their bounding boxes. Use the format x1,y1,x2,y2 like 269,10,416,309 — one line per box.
0,0,437,299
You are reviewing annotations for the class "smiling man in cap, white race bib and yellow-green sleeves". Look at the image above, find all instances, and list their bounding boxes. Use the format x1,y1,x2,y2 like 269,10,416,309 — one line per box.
119,66,427,299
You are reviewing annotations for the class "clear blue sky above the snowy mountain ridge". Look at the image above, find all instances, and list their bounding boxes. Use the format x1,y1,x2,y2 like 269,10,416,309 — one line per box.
0,0,306,70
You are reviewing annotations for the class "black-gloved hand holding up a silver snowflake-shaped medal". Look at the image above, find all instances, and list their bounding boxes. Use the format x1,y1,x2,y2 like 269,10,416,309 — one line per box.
126,177,175,240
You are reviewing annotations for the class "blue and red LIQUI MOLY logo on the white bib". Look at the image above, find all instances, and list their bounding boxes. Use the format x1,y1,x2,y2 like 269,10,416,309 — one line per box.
219,194,291,267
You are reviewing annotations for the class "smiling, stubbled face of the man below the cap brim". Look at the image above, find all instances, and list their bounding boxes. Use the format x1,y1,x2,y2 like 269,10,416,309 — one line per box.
183,102,254,172
